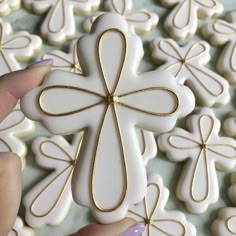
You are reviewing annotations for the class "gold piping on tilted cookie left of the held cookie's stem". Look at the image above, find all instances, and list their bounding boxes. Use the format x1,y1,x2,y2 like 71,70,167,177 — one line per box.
29,135,84,218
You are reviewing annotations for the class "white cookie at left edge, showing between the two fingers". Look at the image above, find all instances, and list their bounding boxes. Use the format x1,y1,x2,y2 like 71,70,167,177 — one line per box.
0,106,34,167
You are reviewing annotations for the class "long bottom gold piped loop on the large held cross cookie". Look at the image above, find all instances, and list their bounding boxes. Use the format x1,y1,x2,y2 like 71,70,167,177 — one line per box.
91,105,129,212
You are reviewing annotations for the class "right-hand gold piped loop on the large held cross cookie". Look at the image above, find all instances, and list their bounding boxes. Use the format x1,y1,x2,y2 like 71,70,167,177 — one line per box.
118,87,179,116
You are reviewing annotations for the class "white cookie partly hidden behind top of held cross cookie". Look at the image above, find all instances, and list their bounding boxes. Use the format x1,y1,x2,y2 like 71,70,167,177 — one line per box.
84,0,159,34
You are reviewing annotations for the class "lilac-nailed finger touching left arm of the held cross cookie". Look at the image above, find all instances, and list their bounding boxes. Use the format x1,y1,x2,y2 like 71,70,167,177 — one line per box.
0,59,52,121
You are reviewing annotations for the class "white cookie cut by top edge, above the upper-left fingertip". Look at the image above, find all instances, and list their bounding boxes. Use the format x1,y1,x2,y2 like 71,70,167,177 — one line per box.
23,0,100,44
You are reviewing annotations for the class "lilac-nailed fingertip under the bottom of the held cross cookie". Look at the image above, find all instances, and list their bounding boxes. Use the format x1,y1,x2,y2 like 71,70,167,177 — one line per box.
70,218,145,236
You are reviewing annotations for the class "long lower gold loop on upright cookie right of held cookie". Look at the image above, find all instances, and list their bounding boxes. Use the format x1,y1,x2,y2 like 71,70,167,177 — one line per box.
191,148,210,203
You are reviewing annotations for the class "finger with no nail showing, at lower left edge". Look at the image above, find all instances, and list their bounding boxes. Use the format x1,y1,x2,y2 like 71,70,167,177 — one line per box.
0,152,21,235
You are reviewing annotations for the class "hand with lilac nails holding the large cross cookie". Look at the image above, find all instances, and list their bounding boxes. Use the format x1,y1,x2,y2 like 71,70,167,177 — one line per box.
0,60,145,236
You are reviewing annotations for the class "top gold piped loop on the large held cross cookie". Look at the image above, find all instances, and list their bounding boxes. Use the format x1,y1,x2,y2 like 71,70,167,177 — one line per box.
97,29,127,95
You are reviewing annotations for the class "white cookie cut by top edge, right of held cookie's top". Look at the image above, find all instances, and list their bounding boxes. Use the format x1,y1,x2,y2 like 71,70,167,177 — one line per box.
159,0,223,40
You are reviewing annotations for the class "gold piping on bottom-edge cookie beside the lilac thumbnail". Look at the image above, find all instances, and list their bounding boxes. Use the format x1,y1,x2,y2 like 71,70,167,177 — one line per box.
129,183,186,236
